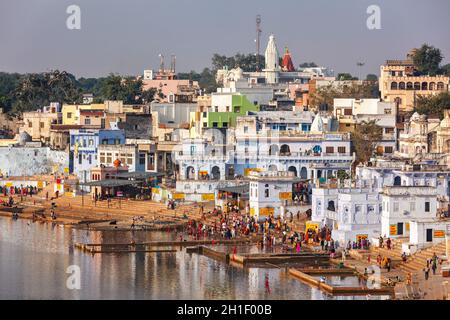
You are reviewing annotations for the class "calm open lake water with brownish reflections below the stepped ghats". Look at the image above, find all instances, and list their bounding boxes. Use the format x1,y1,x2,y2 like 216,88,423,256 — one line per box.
0,218,386,299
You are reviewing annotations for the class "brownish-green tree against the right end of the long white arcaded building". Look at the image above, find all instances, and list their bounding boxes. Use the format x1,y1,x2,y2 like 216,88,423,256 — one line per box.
352,120,383,164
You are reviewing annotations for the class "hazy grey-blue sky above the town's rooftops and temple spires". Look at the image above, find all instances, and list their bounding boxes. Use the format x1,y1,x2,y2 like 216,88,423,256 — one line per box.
0,0,450,77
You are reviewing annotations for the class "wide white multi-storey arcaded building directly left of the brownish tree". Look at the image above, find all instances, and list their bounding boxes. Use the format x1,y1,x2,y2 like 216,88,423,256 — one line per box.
234,113,353,180
